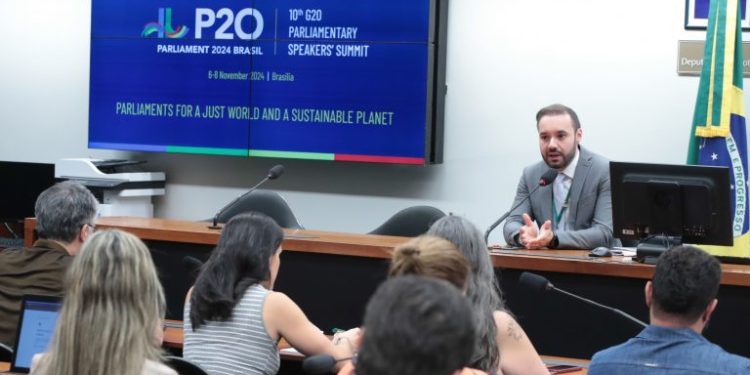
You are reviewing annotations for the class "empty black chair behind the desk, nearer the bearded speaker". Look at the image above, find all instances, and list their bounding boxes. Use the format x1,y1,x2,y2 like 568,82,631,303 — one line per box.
370,206,445,237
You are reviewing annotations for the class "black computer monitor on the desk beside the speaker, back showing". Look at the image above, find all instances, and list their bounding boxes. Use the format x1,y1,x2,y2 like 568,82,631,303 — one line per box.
609,162,733,256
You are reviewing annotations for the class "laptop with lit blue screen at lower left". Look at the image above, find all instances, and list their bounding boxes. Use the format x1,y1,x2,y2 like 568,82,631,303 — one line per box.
10,295,62,374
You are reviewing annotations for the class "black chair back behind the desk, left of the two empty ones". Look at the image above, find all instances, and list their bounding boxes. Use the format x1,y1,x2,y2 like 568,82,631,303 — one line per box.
213,189,305,229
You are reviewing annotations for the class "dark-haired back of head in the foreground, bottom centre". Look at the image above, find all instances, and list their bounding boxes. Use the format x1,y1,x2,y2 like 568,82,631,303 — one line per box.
355,275,475,375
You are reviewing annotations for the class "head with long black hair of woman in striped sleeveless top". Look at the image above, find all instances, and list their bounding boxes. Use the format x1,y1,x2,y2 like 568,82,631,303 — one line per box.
190,212,284,329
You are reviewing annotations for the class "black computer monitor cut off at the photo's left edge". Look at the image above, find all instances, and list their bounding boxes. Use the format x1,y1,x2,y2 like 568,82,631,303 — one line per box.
0,161,55,222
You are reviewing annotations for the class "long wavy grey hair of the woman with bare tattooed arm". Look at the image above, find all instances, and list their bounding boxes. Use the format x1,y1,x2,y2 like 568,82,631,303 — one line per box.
427,215,505,370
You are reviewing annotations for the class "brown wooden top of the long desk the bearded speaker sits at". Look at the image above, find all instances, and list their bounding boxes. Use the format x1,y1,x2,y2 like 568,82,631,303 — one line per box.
24,217,750,287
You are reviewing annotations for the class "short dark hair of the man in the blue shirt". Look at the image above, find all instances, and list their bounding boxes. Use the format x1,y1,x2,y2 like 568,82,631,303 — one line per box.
652,246,721,323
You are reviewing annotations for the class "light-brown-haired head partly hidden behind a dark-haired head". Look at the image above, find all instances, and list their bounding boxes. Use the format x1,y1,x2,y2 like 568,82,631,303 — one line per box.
388,236,471,291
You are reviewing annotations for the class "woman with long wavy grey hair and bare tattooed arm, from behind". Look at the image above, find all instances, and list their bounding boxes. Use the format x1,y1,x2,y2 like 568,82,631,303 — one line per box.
427,216,549,375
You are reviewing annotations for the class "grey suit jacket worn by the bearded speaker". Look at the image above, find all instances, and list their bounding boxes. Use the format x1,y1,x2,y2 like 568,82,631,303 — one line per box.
503,147,612,249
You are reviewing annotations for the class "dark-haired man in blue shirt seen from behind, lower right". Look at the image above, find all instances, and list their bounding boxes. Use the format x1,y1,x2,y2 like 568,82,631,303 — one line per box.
588,246,750,375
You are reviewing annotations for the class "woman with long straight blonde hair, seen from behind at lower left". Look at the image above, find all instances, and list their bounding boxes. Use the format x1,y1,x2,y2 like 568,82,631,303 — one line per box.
31,230,176,375
